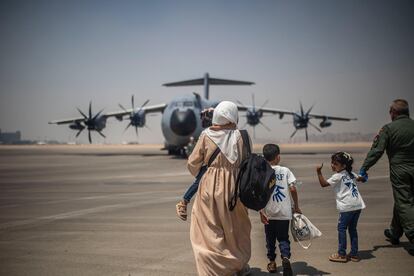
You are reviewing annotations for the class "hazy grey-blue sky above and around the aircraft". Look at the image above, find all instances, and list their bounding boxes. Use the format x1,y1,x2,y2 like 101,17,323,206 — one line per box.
0,0,414,143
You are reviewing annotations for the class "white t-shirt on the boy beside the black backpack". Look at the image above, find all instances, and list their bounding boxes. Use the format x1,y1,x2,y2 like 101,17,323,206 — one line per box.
264,166,296,220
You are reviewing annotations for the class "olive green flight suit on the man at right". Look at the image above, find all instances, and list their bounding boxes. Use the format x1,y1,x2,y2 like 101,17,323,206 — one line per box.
361,115,414,242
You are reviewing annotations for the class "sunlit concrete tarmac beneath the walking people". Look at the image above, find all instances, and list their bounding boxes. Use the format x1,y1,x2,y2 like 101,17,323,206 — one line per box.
0,144,414,276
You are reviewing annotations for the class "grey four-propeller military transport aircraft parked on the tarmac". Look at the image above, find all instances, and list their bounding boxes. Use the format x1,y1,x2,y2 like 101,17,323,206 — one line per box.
49,73,355,154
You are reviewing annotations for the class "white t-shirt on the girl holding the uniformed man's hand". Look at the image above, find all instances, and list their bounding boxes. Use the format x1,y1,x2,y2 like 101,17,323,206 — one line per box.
326,170,365,213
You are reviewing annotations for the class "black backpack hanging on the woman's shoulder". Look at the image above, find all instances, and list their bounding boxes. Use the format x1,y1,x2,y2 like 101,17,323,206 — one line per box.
229,130,276,211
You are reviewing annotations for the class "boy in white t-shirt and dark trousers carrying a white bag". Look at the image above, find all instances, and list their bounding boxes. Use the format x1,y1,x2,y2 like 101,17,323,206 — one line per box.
260,144,301,276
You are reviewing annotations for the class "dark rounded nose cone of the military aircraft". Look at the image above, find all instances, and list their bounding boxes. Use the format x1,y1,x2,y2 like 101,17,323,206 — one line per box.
170,109,197,136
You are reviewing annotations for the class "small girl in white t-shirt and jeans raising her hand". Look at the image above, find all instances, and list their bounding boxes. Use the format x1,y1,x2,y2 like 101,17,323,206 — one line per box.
316,152,365,263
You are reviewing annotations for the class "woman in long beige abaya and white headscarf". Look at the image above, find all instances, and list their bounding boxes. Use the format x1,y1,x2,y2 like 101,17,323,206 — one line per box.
188,101,251,276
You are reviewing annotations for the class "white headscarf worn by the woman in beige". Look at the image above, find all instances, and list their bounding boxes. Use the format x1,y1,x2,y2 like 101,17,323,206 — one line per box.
204,101,240,164
